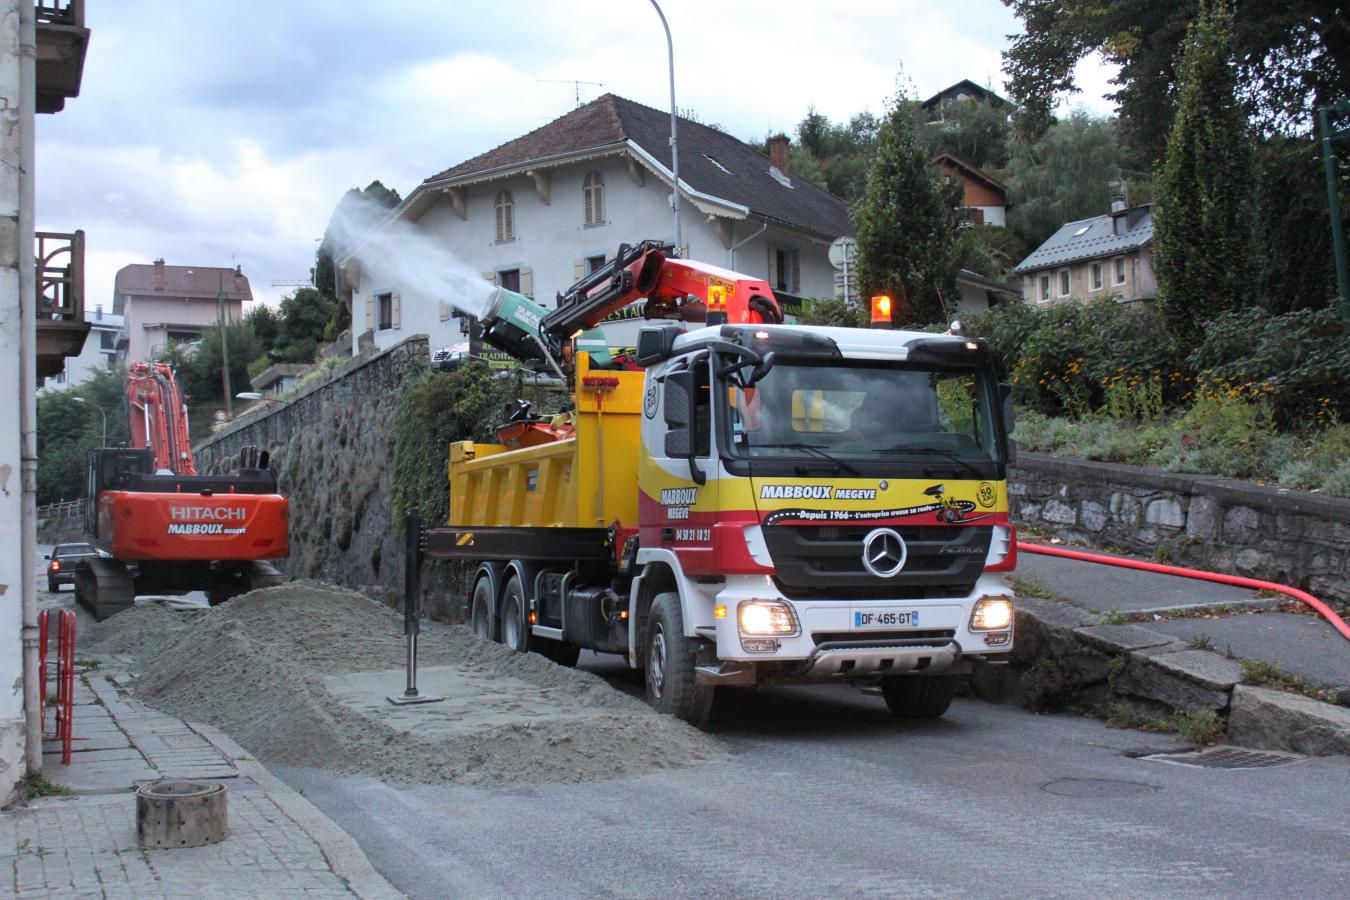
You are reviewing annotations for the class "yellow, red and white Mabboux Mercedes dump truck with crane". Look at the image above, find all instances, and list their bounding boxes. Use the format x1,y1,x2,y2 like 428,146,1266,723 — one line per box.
427,242,1015,725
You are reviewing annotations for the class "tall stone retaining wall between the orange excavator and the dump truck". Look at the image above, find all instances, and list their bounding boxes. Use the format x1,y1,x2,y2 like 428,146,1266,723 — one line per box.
194,335,462,618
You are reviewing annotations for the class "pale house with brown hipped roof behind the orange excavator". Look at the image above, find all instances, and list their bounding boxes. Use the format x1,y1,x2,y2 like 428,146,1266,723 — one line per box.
112,259,252,362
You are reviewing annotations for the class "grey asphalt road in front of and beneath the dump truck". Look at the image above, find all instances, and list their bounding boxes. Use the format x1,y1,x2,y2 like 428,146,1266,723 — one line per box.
273,650,1350,897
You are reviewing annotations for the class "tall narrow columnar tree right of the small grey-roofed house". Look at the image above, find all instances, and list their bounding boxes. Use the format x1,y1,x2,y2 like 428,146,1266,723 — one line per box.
1153,11,1256,347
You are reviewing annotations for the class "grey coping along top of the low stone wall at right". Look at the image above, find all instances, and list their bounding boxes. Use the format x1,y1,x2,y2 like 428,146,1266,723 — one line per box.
1014,451,1350,524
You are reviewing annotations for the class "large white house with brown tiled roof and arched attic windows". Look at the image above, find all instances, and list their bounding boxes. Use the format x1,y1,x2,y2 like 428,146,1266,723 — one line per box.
340,94,853,356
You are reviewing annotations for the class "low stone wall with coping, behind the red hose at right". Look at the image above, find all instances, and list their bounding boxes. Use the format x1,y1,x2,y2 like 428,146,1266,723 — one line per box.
1008,453,1350,603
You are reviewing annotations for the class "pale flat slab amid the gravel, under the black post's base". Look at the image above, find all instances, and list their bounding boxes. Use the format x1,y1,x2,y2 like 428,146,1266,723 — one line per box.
324,665,614,735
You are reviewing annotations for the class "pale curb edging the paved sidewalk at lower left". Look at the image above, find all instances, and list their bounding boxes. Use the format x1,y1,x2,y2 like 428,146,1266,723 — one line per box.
188,722,404,900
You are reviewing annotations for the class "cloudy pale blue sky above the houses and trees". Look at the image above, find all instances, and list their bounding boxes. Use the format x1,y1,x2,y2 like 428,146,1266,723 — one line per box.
38,0,1110,308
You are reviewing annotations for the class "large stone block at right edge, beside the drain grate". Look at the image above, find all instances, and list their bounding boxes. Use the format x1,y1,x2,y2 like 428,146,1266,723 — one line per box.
1229,684,1350,756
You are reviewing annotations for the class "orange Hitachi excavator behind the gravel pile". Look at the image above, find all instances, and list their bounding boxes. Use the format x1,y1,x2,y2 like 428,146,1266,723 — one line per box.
76,363,290,619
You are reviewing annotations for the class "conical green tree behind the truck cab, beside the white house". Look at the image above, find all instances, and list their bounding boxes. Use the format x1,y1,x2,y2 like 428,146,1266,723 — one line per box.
857,96,956,325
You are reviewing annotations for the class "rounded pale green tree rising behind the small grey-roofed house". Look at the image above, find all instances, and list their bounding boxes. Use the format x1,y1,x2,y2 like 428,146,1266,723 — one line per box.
1007,112,1138,248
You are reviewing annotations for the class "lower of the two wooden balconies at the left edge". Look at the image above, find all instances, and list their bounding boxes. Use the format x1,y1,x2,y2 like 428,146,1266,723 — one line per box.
35,231,89,378
